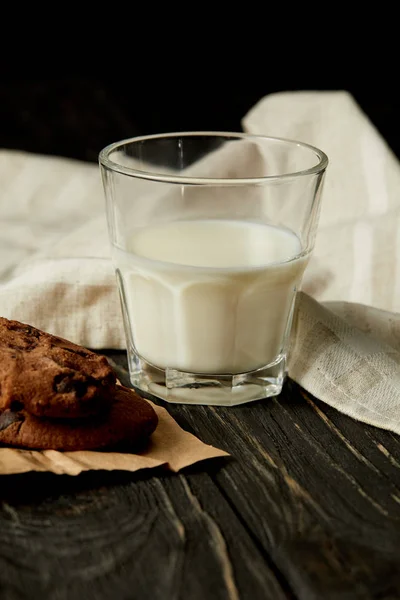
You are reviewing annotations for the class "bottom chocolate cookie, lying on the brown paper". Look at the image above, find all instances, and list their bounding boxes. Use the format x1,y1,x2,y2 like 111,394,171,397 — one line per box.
0,385,158,451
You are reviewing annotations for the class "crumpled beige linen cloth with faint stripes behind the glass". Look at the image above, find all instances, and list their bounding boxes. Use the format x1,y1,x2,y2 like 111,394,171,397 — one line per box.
0,92,400,433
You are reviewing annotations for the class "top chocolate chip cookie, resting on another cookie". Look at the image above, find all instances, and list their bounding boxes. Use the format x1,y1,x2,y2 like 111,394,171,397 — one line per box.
0,317,116,418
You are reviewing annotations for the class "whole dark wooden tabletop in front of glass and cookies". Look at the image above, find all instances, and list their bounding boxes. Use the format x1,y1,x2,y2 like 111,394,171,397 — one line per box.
0,353,400,600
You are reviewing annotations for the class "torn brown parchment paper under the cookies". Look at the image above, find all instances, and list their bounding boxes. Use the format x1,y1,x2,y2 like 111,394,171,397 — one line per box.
0,401,228,475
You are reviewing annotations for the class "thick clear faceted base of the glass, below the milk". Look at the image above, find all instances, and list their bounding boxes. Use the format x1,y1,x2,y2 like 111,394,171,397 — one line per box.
128,351,286,406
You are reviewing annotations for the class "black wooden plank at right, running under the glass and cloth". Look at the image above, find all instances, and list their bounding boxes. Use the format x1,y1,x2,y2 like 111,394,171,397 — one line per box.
105,355,400,600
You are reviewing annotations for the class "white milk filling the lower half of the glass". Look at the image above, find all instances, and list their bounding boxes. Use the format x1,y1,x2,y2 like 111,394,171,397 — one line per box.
114,220,307,374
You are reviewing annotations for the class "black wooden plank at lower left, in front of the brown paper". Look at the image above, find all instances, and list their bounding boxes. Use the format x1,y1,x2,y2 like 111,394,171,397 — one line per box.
0,458,290,600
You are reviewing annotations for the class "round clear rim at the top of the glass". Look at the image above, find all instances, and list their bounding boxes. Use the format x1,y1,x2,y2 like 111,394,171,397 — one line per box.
98,131,329,185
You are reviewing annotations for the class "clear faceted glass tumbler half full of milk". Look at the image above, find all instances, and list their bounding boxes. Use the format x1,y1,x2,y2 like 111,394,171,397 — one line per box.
99,132,328,406
